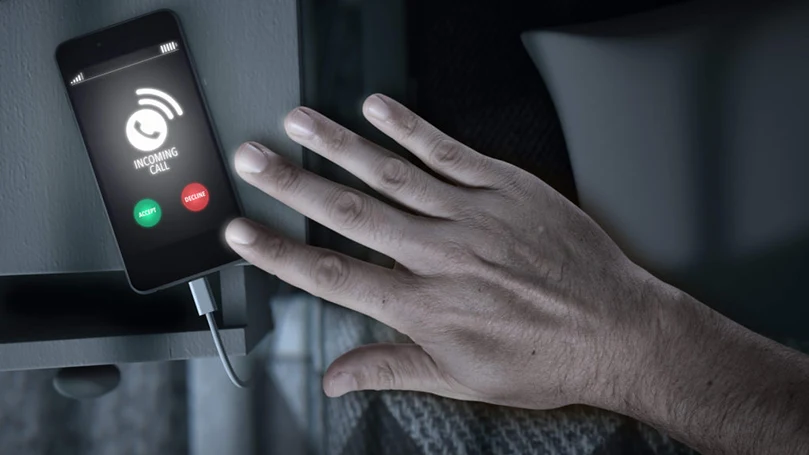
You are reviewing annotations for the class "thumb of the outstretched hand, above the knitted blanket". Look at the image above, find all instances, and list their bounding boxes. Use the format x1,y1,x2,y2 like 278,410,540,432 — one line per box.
323,343,447,397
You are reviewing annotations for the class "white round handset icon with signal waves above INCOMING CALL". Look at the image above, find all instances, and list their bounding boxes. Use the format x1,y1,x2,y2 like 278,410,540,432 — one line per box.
126,88,183,152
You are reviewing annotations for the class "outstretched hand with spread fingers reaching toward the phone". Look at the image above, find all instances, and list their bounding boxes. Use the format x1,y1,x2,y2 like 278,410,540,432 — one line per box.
227,95,657,408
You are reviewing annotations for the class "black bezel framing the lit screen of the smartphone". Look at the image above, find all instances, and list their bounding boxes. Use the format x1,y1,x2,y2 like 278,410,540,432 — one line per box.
55,9,244,294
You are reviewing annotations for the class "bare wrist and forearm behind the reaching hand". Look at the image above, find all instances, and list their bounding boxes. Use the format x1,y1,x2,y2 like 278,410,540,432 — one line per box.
597,268,809,453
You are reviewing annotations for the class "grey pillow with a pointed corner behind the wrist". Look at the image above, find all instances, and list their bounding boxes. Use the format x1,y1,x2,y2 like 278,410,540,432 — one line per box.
523,0,809,339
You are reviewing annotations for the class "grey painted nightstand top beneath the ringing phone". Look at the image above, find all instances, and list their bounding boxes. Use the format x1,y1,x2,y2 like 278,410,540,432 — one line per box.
0,0,305,276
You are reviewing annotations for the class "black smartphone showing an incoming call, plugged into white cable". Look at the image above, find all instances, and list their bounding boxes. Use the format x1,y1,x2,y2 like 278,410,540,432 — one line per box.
56,10,242,294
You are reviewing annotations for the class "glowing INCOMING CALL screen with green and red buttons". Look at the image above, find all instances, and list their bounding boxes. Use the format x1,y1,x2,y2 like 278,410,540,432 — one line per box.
68,41,238,256
